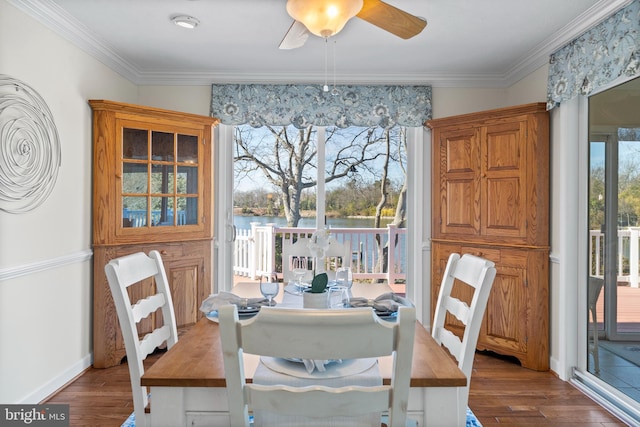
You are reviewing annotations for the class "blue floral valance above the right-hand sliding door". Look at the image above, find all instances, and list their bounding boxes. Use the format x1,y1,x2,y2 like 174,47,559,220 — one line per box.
547,0,640,109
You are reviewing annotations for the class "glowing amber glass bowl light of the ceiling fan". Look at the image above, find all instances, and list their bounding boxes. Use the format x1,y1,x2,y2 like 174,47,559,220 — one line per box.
287,0,363,38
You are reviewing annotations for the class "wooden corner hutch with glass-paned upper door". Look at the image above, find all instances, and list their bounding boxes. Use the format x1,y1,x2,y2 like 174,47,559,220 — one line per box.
89,100,219,368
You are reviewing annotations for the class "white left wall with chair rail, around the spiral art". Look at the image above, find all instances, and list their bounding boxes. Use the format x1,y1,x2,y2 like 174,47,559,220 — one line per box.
0,0,138,403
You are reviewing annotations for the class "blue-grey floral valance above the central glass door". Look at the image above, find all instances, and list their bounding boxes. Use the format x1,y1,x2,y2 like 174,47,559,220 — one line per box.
211,84,431,129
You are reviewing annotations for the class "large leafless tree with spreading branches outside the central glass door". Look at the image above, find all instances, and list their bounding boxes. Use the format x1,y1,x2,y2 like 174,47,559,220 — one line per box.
234,126,392,227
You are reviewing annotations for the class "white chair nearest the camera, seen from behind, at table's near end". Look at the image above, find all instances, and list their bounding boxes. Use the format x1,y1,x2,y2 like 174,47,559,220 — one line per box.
218,305,416,427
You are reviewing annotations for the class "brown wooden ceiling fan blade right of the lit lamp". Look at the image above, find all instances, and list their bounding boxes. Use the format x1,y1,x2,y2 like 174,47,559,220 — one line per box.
357,0,427,39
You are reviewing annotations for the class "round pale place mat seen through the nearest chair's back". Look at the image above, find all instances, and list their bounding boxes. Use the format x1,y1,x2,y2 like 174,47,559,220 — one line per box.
260,356,378,379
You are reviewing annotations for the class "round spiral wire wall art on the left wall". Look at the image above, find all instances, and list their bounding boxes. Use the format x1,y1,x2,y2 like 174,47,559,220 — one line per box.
0,74,62,213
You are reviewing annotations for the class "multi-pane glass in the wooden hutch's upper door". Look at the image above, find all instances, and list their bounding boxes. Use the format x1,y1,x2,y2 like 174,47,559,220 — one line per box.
121,125,202,228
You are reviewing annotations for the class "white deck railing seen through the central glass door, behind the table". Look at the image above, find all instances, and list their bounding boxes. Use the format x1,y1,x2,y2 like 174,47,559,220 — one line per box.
233,223,407,284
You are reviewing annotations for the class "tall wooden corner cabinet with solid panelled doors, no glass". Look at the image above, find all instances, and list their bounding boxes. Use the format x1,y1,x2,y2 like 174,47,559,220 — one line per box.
426,103,549,370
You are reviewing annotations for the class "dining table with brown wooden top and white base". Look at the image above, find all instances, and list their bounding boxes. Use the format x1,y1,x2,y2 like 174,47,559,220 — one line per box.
141,282,467,427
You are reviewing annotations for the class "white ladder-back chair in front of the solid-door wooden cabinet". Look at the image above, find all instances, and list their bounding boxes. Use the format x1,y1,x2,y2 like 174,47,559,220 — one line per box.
431,253,496,426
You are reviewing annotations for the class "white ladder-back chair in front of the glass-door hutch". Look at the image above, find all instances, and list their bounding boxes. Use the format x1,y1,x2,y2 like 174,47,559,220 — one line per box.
105,251,178,427
